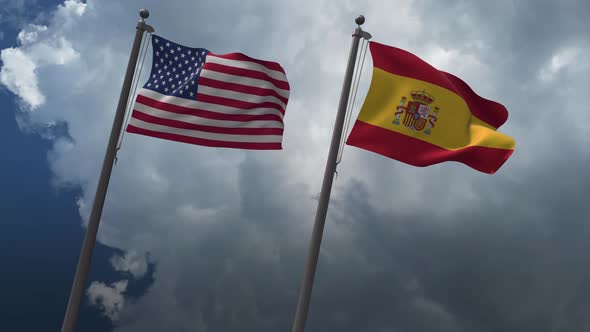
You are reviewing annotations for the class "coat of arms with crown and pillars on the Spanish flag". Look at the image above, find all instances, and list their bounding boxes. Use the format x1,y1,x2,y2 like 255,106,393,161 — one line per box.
393,90,440,135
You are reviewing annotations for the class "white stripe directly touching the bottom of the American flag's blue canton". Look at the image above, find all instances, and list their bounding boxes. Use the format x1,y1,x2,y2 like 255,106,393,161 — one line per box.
139,89,283,119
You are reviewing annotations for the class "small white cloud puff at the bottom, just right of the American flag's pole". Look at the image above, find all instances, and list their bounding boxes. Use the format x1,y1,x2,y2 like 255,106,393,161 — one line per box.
86,280,127,320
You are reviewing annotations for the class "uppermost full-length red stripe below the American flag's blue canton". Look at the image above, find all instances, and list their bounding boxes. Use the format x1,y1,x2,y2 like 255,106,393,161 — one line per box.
136,95,283,123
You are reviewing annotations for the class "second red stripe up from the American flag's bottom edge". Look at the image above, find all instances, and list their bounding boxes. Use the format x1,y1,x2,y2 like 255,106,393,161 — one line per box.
131,110,283,136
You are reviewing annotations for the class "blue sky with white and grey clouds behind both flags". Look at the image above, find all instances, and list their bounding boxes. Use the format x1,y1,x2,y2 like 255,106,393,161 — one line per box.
0,0,590,332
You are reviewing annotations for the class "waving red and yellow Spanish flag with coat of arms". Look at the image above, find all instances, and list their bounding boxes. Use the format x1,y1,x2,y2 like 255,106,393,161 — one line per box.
346,42,514,174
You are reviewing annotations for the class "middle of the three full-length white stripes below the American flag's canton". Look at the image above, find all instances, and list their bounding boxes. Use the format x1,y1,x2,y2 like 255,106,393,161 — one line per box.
133,103,284,128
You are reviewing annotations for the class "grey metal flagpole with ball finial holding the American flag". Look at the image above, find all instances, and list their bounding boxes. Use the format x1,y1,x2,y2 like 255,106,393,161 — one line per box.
61,9,154,332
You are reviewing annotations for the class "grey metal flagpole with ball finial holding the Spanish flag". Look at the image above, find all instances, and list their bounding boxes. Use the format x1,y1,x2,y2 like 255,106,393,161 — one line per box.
292,15,368,332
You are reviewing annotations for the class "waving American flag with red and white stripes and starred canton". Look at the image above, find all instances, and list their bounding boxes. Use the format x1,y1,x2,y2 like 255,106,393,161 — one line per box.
127,35,289,150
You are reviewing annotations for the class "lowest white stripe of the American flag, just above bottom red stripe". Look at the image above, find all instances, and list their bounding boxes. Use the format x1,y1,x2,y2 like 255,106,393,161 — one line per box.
129,118,283,143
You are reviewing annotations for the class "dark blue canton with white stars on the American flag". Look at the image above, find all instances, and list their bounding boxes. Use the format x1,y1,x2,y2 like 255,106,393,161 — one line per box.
143,35,209,100
